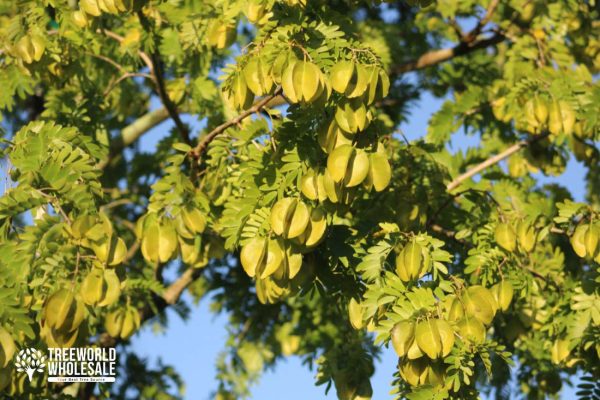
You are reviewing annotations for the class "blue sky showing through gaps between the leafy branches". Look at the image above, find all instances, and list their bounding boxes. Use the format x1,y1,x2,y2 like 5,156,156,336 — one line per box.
132,89,585,400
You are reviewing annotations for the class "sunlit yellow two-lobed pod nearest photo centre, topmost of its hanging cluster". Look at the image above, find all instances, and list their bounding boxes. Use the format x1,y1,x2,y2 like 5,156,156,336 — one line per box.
271,197,310,239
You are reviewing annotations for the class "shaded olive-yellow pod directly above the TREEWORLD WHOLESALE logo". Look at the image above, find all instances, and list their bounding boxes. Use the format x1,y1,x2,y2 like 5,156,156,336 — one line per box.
44,289,85,333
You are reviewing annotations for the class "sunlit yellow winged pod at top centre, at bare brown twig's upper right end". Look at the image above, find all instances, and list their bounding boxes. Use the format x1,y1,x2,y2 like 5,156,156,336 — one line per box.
281,60,326,103
